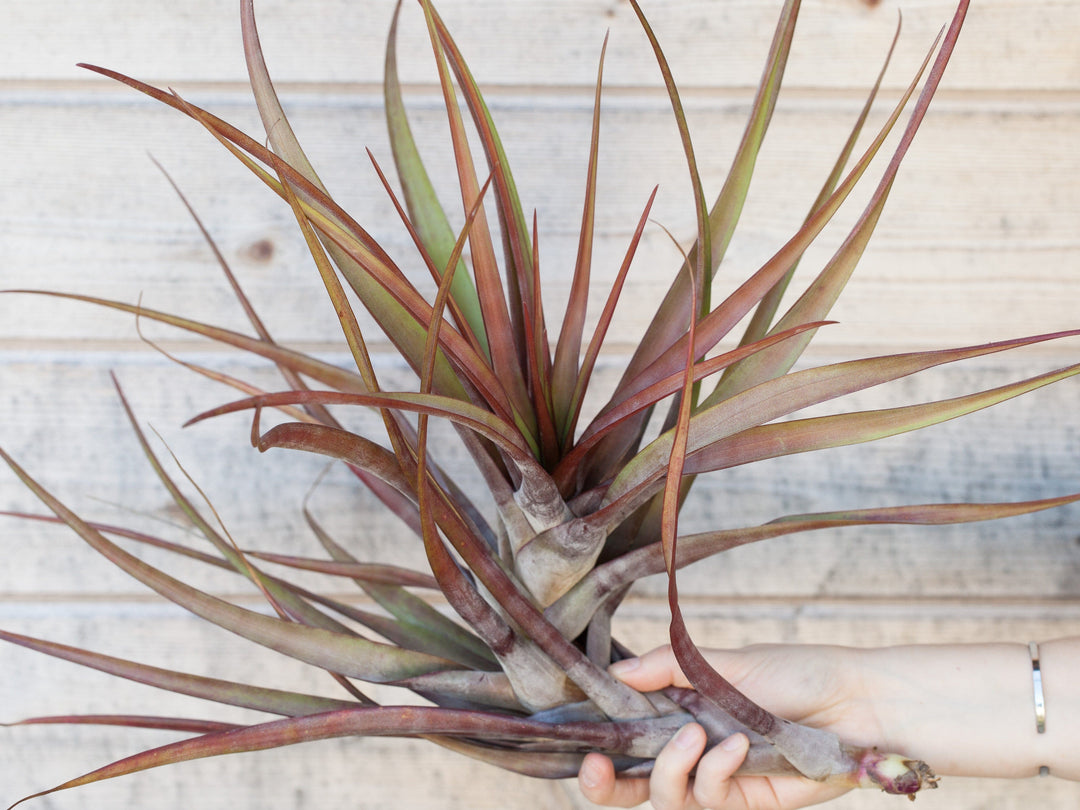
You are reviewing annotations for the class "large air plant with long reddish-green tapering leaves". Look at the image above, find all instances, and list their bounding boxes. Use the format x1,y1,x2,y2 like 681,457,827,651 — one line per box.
0,0,1080,798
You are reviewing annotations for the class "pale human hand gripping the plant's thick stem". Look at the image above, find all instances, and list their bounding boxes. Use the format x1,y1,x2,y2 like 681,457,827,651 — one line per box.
579,645,881,810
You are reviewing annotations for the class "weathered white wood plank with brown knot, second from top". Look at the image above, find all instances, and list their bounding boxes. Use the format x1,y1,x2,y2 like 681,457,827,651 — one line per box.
0,94,1080,347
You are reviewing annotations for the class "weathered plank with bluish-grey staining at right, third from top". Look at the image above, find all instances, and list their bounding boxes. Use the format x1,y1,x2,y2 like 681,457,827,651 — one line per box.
0,354,1080,598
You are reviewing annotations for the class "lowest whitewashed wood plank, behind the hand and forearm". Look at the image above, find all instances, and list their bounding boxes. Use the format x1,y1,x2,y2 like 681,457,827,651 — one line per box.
0,602,1080,810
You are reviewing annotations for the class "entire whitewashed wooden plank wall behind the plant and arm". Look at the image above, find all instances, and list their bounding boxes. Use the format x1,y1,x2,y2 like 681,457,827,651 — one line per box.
0,0,1080,810
